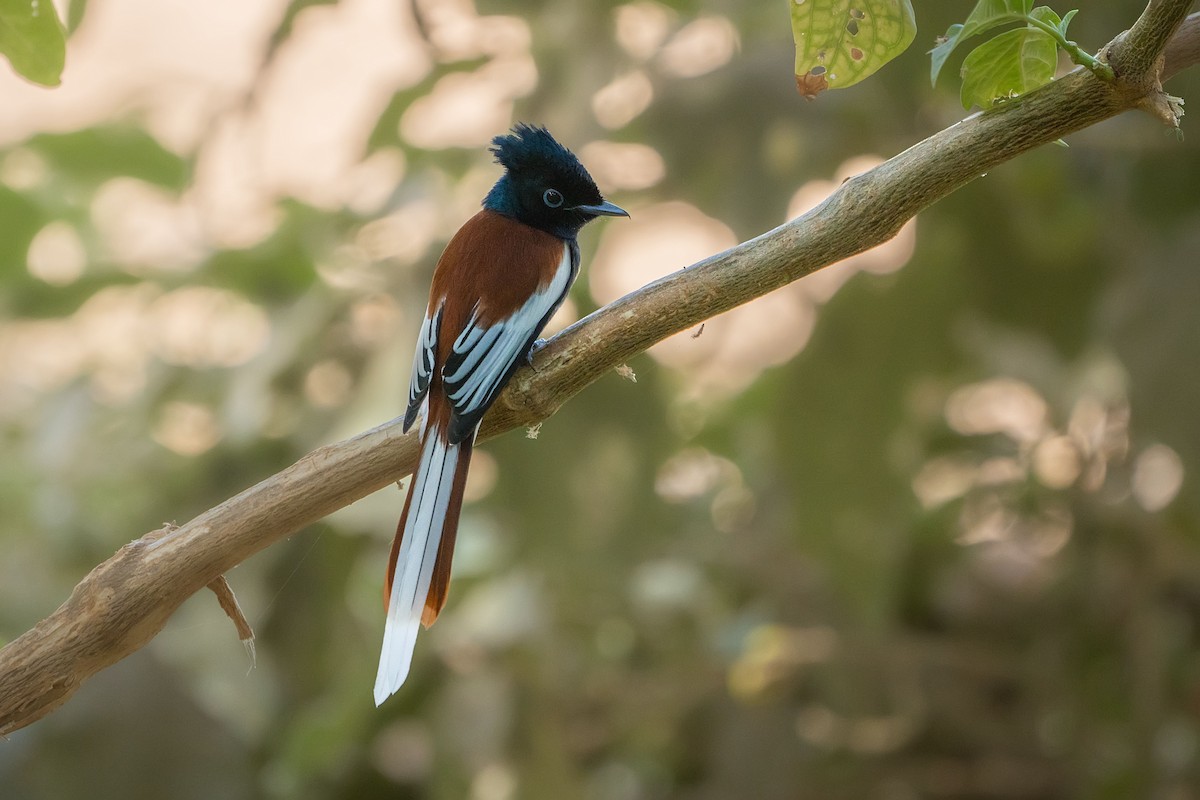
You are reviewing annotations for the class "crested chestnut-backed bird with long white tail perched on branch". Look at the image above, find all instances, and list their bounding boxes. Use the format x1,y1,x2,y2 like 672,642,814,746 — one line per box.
374,122,629,706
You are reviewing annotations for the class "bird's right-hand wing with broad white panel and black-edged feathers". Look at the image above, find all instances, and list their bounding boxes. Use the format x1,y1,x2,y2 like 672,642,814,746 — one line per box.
442,246,578,441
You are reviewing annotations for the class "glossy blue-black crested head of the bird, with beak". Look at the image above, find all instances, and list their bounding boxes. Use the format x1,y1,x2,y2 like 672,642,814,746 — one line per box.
484,122,629,239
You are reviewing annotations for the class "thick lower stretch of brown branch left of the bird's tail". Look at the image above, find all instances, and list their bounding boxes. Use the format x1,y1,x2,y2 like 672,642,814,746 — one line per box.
0,422,416,734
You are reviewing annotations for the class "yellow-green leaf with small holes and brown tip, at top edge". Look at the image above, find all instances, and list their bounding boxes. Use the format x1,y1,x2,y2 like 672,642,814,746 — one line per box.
788,0,917,97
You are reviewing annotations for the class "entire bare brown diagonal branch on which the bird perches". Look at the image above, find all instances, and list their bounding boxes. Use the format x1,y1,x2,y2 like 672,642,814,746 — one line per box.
0,0,1200,734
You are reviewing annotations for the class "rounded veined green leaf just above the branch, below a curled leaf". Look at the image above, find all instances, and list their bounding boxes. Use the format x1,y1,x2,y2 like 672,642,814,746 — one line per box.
961,22,1058,109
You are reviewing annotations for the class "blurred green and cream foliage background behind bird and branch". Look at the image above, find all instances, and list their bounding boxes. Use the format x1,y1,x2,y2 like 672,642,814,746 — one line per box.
0,0,1200,800
